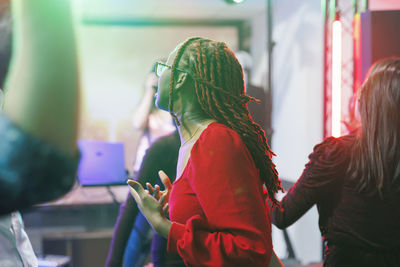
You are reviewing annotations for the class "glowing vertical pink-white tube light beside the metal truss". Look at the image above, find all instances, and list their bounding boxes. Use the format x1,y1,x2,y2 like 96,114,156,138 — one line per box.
332,20,342,137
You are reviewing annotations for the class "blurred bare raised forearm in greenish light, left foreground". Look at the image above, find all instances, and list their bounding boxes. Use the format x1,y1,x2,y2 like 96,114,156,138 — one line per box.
5,0,78,155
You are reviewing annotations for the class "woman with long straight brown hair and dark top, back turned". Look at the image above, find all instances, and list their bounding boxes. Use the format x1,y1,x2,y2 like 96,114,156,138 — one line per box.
271,58,400,267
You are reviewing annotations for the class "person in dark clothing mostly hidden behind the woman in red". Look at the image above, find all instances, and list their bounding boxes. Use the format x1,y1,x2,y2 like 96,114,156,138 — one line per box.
106,131,180,267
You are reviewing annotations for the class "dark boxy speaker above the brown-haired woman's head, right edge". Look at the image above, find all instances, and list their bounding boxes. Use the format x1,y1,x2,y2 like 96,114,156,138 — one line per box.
361,10,400,81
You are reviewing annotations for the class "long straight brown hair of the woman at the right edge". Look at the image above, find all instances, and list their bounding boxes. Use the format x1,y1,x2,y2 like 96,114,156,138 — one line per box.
348,58,400,197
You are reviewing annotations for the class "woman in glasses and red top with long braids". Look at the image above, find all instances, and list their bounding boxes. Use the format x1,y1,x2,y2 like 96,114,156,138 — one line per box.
128,38,281,266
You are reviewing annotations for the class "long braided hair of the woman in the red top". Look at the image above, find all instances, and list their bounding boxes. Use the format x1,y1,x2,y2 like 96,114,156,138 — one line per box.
169,37,283,205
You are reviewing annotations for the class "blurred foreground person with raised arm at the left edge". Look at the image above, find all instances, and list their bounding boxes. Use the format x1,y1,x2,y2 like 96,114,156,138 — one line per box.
0,0,79,267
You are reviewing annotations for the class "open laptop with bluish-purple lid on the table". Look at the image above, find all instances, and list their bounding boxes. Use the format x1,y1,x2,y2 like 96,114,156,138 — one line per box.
78,140,127,186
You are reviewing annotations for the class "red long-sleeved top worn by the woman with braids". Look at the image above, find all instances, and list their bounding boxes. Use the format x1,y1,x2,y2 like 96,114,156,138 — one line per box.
168,122,272,266
